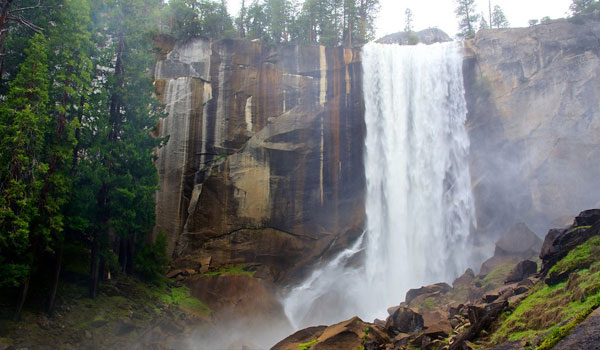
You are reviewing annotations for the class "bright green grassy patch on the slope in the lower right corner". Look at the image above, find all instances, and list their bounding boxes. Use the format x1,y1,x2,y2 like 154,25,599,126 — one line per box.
491,237,600,349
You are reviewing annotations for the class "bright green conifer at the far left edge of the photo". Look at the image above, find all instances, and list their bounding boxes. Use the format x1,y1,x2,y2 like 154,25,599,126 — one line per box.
0,34,49,289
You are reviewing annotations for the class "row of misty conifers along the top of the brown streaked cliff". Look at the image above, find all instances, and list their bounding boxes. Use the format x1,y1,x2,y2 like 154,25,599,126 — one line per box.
163,0,379,47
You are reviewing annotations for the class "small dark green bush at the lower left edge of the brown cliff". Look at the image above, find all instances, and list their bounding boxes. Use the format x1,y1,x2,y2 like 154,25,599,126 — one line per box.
135,232,169,284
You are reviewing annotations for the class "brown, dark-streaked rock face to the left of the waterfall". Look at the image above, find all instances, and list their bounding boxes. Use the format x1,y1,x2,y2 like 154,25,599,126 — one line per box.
155,38,365,281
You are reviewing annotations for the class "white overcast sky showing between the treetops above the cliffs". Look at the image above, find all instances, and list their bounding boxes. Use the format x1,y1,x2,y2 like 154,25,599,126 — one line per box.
228,0,572,38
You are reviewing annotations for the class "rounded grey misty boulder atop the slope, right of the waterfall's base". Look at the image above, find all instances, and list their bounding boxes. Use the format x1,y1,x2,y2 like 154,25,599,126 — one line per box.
494,223,542,259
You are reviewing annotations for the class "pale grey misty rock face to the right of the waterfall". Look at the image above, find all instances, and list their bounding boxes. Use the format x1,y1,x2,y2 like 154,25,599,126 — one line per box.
464,20,600,238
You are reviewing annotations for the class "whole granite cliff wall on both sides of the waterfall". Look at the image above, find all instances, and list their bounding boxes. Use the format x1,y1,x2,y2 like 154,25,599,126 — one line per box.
155,20,600,320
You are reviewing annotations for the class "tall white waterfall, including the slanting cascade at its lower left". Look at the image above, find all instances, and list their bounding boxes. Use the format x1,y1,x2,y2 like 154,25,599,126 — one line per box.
283,43,474,328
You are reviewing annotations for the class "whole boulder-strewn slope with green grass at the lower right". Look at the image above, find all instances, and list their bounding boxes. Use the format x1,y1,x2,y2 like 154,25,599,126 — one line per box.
272,209,600,350
